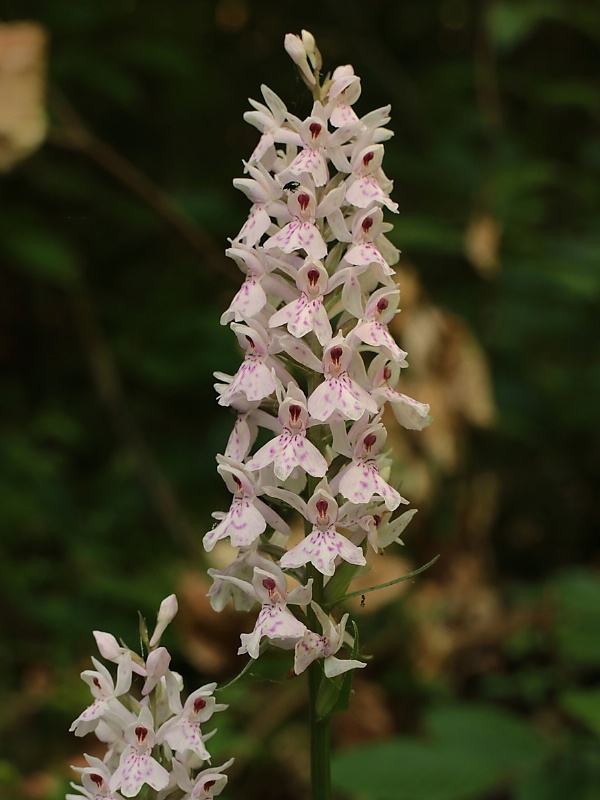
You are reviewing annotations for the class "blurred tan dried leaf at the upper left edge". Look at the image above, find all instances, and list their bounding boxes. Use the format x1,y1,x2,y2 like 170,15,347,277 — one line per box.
0,22,47,172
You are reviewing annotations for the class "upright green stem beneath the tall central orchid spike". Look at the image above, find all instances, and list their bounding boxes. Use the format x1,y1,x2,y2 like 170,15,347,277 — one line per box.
308,567,331,800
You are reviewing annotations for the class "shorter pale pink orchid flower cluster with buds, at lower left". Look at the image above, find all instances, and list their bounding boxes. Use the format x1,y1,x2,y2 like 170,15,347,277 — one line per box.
66,595,233,800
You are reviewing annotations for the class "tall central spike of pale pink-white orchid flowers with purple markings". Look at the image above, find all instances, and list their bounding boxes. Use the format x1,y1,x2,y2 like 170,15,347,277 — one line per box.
203,31,430,677
